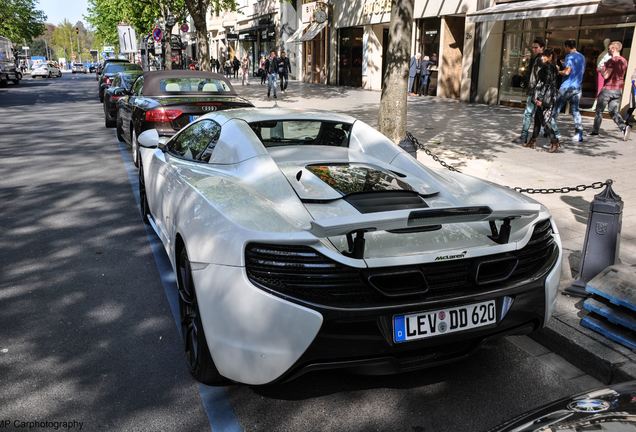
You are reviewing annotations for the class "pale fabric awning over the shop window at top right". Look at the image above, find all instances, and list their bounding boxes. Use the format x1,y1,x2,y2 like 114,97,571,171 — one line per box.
466,0,601,22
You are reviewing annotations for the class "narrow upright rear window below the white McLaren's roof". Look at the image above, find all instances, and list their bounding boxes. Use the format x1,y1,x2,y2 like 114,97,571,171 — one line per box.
250,120,351,147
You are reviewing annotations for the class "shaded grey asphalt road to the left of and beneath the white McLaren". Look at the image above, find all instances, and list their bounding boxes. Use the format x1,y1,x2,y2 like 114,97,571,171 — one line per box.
0,74,608,432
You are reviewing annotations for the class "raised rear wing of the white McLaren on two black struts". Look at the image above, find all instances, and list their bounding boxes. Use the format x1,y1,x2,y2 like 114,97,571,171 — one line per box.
309,203,541,258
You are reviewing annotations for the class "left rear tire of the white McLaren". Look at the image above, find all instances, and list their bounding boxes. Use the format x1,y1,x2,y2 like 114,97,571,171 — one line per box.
177,247,228,385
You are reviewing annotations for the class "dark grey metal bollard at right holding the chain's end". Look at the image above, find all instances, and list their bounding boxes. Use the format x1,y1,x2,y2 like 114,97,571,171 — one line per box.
564,180,623,297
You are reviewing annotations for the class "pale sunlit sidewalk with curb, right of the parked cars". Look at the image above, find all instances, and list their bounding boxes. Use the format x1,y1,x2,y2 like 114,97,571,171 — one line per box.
232,78,636,383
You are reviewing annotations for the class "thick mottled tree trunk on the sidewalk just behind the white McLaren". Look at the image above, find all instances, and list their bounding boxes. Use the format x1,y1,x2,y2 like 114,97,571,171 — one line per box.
378,0,415,144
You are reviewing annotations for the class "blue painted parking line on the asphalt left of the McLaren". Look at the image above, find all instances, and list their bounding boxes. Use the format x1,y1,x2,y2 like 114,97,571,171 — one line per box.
119,142,243,432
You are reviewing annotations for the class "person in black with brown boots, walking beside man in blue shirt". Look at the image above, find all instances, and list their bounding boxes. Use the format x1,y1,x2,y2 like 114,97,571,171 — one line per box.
524,48,560,153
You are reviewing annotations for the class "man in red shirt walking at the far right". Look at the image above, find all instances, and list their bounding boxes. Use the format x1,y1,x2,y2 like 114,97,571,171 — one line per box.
590,41,627,139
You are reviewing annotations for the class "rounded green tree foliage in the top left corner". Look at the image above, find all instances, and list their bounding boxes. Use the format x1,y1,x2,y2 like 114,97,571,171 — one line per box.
0,0,46,42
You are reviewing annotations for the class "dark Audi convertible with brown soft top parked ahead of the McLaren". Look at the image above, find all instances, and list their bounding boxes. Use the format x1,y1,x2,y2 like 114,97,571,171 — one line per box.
117,70,254,165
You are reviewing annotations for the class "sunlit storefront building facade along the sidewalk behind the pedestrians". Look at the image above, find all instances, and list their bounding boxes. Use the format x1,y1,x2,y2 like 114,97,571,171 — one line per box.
208,0,636,110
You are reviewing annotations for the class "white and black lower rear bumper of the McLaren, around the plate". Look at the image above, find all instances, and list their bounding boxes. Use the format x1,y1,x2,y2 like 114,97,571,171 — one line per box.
193,243,560,385
